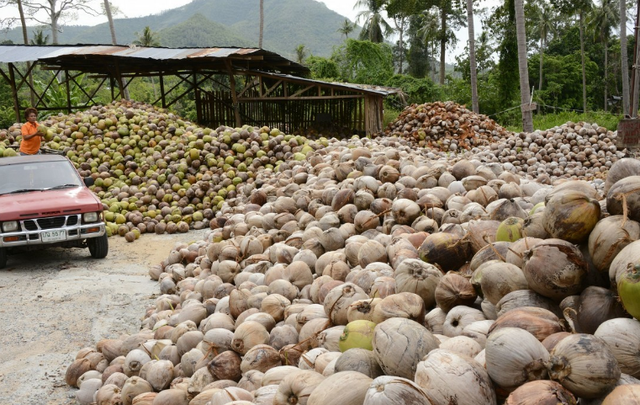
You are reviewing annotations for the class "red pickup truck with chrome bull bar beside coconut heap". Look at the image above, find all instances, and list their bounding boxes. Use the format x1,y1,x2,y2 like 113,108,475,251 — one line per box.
0,154,109,268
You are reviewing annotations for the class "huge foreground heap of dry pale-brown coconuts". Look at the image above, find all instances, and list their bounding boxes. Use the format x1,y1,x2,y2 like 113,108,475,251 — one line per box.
57,99,640,405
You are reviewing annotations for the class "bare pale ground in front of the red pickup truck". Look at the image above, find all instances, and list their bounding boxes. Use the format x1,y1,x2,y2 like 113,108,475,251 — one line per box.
0,230,206,405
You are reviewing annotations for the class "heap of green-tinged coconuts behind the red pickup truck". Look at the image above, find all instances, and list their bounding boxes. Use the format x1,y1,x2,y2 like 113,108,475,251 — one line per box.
0,101,324,242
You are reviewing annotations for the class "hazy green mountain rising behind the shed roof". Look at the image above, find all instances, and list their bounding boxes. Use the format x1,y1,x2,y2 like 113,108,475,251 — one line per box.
0,0,358,59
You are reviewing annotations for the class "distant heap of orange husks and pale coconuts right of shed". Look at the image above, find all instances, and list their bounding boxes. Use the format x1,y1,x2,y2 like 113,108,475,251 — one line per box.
384,101,629,183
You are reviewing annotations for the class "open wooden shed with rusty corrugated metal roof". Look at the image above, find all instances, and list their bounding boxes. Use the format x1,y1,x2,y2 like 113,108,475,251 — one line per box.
0,45,400,134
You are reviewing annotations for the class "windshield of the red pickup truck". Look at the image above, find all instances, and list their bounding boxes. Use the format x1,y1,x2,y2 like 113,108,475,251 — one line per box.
0,161,82,194
